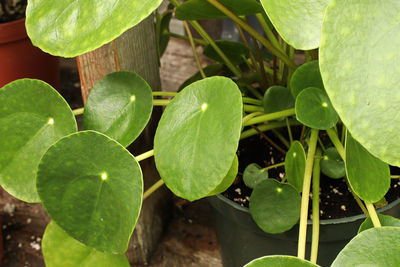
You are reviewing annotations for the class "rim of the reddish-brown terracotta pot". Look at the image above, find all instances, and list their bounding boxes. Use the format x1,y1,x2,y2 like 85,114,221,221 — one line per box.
0,18,28,44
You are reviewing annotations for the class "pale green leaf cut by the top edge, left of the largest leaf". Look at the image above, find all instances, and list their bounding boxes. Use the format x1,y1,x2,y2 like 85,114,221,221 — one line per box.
261,0,329,50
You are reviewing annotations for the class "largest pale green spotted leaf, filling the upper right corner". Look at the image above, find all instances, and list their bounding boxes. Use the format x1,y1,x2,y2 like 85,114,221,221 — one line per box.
320,0,400,166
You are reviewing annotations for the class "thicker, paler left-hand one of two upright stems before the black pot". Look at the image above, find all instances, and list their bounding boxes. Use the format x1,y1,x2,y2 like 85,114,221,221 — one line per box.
297,129,319,260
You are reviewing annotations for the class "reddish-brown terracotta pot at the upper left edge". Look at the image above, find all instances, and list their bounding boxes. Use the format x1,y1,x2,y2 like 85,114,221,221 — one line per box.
0,18,60,88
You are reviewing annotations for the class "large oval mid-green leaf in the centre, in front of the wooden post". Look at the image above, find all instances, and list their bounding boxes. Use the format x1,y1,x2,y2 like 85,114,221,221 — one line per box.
154,76,243,201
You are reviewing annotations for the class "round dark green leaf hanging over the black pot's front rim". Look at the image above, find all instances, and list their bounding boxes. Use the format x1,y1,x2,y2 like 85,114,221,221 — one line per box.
250,179,301,234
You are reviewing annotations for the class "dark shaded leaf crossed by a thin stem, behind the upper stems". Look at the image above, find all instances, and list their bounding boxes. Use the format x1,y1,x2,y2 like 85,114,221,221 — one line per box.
203,40,249,65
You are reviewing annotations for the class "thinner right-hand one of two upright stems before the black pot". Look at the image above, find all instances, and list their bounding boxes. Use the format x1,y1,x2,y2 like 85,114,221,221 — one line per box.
310,149,321,264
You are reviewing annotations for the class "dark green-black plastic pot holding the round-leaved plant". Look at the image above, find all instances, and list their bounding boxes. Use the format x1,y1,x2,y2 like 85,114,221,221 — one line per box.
208,195,400,267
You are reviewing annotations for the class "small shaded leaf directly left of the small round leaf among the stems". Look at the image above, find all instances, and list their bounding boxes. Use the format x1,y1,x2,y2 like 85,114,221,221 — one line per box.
263,86,294,114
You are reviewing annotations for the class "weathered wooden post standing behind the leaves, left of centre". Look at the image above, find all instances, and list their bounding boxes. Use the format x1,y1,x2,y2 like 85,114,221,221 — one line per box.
77,15,170,264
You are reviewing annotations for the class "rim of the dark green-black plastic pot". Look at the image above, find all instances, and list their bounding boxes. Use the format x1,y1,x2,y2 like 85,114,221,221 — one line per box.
215,194,400,225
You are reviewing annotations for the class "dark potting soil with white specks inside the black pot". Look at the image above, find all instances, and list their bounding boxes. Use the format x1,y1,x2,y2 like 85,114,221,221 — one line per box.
223,131,400,219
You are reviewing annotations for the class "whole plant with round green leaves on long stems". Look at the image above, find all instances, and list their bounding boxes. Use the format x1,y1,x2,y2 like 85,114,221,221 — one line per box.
0,0,400,266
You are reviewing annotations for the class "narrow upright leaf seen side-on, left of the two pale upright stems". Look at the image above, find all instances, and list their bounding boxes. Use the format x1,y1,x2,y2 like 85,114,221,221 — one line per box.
285,141,306,192
